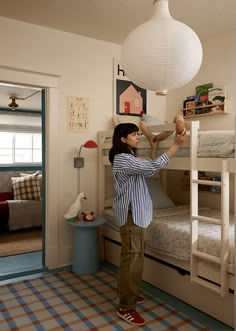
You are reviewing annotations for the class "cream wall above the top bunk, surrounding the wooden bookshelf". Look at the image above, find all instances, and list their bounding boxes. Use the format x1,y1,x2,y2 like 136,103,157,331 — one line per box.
166,32,236,130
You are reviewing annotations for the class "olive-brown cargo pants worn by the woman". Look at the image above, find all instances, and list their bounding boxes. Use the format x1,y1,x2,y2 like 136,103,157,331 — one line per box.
117,211,145,309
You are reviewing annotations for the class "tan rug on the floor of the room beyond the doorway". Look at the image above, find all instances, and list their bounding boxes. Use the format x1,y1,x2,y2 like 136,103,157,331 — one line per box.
0,230,42,257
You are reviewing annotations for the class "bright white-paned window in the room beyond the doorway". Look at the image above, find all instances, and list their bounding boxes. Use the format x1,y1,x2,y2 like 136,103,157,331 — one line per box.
0,132,42,165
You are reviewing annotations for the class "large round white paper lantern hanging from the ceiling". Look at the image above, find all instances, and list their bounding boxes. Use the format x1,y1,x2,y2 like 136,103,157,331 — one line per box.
121,0,202,95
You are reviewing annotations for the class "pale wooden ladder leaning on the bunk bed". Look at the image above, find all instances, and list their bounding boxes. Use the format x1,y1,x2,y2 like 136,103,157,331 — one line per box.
190,122,229,296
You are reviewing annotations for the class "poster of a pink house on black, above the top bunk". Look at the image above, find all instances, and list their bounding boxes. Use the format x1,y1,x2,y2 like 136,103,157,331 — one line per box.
113,59,147,116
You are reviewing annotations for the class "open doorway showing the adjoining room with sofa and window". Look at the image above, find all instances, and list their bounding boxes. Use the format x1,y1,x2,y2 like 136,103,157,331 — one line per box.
0,82,46,280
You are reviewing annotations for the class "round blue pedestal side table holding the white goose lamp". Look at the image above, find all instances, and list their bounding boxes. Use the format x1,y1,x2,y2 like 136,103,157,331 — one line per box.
66,216,107,275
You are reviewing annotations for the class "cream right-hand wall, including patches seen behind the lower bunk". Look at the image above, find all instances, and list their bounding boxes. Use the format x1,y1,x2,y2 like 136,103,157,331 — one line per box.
166,32,236,212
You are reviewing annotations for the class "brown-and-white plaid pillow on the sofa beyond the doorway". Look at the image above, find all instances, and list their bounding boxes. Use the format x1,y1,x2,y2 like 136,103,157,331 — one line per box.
11,173,41,200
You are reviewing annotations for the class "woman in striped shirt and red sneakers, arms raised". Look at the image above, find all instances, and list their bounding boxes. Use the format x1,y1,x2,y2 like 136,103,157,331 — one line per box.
109,123,186,326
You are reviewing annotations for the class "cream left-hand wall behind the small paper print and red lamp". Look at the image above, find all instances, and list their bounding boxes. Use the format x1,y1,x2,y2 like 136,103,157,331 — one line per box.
0,17,165,268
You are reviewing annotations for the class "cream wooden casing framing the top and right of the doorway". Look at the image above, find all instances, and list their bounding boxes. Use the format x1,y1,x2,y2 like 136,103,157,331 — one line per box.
0,66,60,269
